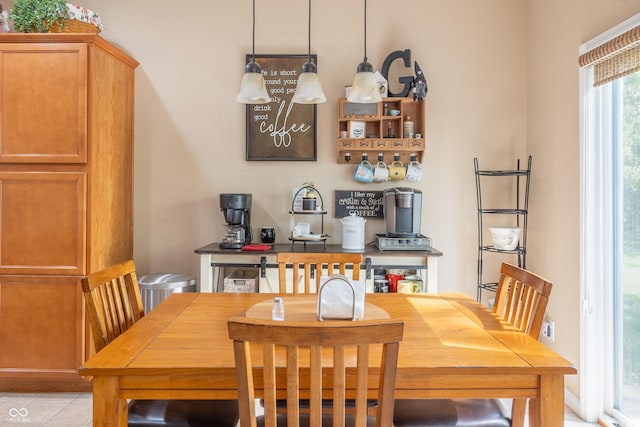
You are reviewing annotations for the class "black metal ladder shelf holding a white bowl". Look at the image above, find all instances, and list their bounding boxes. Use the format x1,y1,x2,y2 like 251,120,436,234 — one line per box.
473,156,531,302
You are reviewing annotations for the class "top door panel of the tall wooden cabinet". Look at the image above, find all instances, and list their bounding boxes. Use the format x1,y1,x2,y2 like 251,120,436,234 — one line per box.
0,43,87,163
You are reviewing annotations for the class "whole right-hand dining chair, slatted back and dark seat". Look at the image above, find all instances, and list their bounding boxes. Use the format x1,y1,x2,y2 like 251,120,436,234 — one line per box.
393,263,553,427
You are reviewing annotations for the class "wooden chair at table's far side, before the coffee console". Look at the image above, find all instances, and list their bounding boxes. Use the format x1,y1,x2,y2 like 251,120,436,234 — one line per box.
277,252,362,295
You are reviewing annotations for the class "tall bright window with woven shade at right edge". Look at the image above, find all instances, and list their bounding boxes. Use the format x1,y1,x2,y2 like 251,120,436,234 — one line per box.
580,11,640,426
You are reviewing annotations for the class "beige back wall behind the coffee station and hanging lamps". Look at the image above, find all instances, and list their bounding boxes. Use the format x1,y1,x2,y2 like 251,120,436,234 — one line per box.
70,0,526,294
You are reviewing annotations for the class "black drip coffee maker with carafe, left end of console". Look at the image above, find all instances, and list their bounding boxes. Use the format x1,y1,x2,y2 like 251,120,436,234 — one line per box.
220,194,253,249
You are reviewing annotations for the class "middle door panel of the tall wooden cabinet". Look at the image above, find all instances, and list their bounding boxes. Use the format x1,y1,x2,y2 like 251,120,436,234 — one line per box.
0,169,86,275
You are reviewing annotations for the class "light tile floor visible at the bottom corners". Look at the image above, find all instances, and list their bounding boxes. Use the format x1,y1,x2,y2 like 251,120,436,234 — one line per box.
0,392,597,427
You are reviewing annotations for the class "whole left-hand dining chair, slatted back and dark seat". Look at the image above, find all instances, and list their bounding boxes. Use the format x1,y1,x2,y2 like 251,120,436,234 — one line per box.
81,260,238,427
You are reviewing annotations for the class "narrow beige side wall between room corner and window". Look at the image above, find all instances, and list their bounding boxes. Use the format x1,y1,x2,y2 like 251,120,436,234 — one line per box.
526,0,640,395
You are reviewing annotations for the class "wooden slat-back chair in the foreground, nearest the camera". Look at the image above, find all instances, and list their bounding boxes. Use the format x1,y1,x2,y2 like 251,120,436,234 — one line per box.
228,317,404,427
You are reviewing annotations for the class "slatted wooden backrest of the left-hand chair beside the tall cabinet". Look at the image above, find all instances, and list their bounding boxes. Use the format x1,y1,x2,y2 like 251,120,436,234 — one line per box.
81,260,144,352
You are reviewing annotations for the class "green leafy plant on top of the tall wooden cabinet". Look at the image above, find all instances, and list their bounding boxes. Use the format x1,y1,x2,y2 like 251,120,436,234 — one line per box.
9,0,69,33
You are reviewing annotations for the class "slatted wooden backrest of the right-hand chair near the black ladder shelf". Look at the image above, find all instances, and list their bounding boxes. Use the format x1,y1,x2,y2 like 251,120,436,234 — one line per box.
493,263,553,339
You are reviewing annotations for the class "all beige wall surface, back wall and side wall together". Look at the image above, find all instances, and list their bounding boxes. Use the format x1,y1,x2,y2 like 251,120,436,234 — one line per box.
3,0,640,404
